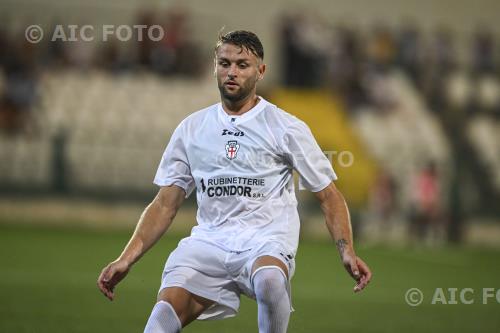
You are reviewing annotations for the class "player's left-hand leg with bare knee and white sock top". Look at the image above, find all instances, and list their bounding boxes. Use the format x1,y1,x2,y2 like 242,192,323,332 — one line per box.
144,287,214,333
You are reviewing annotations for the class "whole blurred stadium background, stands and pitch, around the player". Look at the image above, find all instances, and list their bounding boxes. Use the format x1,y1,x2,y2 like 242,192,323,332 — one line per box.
0,0,500,332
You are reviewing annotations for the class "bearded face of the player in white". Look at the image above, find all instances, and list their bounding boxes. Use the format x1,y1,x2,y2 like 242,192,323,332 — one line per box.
215,44,265,102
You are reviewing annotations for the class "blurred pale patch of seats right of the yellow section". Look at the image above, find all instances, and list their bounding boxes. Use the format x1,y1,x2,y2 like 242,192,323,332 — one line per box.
354,71,450,209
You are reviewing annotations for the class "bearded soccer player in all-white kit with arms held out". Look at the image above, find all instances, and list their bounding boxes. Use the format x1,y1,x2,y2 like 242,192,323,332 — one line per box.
97,31,371,333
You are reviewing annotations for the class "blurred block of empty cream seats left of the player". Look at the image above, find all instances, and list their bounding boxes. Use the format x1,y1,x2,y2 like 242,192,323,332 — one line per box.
1,71,217,190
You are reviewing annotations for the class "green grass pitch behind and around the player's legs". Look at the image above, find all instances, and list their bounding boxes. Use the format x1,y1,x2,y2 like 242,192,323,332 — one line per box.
0,220,500,333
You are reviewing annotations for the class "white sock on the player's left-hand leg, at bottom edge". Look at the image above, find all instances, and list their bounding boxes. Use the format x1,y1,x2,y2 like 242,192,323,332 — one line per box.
144,301,182,333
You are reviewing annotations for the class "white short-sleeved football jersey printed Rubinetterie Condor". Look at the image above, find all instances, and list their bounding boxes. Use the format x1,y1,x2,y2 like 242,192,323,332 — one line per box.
154,98,337,254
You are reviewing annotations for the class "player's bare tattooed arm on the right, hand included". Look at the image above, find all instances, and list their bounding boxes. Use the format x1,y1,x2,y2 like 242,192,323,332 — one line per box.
315,183,372,292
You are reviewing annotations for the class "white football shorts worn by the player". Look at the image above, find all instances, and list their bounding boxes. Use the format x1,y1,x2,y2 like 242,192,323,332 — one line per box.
160,237,295,320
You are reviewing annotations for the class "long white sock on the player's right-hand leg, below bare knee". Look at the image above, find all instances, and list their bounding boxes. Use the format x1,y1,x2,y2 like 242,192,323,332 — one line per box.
252,266,291,333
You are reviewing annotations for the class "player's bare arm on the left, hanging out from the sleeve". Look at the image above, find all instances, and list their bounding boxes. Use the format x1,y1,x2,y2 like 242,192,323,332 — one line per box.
97,186,185,300
